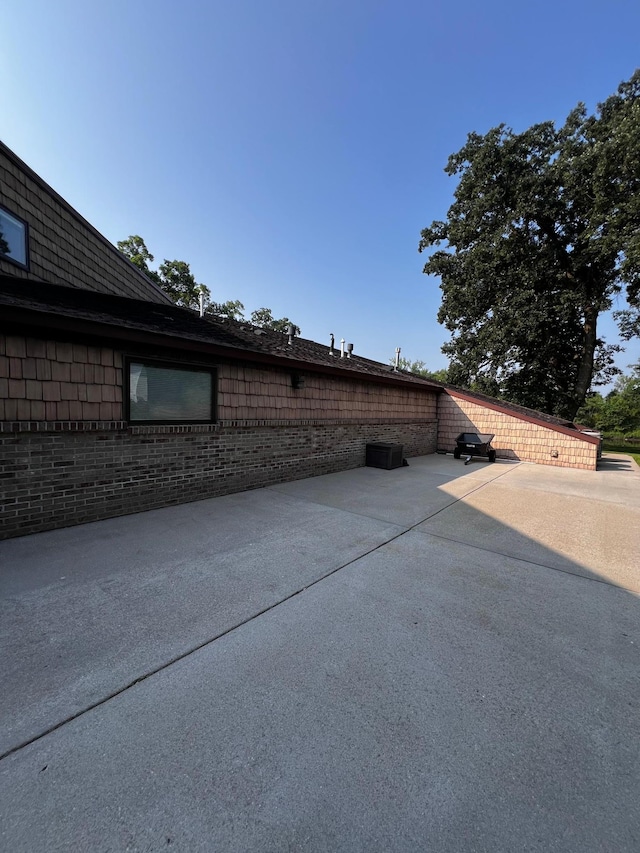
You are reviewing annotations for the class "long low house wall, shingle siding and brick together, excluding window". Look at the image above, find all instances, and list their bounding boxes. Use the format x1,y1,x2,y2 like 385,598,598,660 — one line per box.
0,335,437,538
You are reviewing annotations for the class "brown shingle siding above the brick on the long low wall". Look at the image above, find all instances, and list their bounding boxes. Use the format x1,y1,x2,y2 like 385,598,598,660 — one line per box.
0,334,437,422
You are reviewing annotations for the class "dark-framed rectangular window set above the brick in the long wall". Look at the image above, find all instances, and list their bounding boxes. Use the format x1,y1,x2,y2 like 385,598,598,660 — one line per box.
129,361,213,423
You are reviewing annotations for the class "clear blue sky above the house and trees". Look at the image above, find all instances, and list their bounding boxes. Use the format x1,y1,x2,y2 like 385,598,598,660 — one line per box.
0,0,640,380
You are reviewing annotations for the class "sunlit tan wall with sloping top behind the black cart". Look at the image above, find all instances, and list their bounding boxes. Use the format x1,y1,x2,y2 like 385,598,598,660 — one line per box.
438,392,598,471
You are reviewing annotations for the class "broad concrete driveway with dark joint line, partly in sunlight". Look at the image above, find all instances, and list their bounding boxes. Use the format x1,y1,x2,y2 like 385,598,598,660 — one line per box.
0,456,640,853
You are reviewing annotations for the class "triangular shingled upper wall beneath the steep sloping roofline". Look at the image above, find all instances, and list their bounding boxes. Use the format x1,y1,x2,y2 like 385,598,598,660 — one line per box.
0,143,169,305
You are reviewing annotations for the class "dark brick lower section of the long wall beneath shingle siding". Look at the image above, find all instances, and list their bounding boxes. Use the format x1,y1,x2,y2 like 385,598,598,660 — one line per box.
0,421,436,538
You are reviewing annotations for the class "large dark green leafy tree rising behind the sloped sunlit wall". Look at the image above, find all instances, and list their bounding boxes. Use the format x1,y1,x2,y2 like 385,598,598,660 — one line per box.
419,71,640,418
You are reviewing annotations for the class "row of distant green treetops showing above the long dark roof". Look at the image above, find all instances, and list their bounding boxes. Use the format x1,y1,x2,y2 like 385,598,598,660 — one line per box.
117,240,300,335
